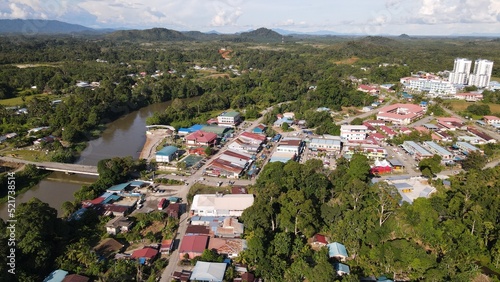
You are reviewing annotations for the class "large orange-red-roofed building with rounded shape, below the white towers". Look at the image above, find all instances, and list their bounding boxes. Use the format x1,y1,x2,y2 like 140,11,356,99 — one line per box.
377,104,425,125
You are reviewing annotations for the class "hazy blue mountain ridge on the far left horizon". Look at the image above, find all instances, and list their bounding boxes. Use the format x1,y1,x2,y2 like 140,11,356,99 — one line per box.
0,19,96,35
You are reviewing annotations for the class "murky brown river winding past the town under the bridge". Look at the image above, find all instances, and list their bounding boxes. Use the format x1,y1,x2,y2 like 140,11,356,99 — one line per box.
0,97,198,219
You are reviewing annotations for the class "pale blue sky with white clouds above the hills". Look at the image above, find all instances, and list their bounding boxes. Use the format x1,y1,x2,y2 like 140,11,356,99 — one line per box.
0,0,500,35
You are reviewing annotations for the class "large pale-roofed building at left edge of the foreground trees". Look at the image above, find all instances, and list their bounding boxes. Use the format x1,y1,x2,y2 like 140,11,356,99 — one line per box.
191,194,254,217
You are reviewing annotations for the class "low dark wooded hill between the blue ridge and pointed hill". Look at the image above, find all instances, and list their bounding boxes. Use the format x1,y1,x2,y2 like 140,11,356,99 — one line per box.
106,28,193,41
